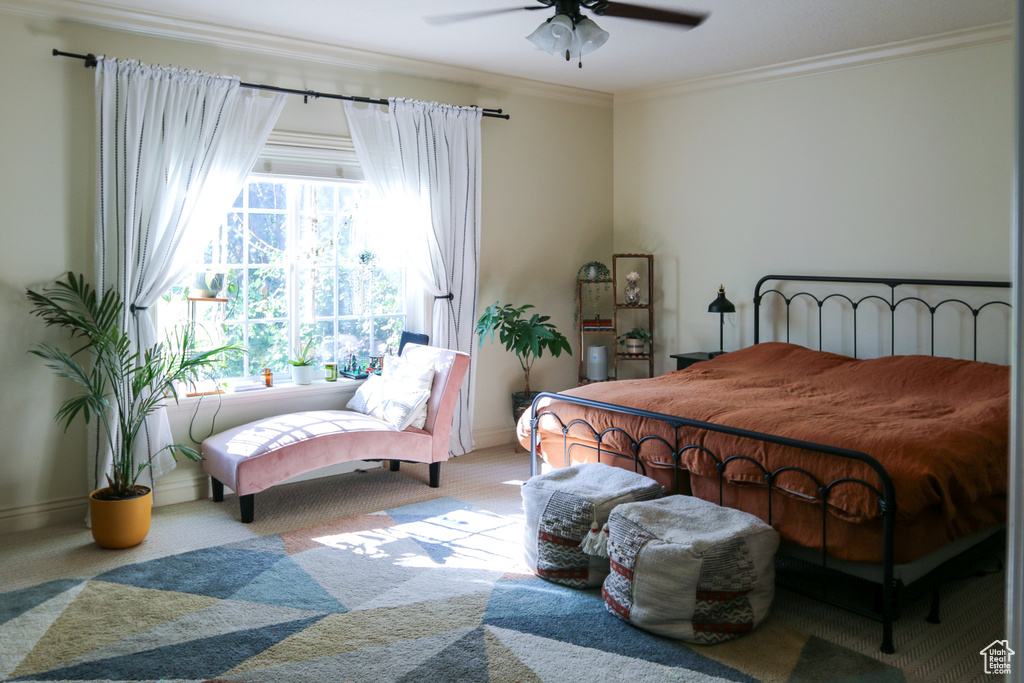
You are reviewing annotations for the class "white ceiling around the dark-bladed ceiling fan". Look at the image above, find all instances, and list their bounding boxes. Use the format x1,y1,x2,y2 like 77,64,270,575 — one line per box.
66,0,1013,94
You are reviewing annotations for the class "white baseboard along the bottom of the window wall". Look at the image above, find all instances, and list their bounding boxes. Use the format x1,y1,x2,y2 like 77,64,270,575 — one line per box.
0,425,515,533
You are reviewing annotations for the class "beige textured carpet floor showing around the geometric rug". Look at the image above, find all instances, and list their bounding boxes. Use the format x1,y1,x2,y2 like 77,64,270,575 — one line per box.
0,445,1005,683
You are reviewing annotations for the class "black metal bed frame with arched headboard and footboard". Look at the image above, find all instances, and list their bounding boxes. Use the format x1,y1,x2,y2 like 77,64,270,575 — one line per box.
530,275,1011,653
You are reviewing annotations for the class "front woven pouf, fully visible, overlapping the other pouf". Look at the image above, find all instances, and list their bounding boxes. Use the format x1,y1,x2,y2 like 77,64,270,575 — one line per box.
601,496,778,644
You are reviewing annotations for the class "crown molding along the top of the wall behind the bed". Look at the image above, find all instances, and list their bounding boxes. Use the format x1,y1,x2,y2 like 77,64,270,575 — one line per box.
614,22,1014,106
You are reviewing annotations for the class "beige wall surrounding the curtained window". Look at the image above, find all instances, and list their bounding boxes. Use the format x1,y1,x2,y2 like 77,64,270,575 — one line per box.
0,13,612,532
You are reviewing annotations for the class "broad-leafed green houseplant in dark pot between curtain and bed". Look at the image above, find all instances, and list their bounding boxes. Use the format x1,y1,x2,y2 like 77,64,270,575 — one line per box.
476,301,572,421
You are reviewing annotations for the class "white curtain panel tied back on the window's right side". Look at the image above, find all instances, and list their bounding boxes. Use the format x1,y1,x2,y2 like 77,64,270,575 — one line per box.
345,98,481,456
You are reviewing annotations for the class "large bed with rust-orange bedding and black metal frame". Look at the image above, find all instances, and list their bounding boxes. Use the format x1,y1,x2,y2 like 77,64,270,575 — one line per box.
519,275,1010,652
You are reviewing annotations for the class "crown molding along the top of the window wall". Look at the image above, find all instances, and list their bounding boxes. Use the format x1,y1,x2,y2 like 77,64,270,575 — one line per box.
0,0,612,108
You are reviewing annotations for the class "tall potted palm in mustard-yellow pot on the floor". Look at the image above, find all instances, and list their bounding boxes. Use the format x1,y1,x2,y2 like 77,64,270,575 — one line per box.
27,272,241,548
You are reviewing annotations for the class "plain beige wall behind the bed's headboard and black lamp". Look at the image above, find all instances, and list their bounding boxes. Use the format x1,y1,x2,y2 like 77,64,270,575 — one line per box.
614,40,1014,372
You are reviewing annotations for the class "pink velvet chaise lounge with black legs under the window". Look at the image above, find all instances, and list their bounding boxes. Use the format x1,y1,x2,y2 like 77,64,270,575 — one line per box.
202,344,469,522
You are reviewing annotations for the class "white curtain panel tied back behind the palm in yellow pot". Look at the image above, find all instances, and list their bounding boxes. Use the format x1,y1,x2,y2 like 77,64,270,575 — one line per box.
89,57,286,488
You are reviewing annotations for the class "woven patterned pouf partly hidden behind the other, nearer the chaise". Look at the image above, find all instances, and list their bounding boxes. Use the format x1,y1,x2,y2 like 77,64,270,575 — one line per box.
522,463,665,588
